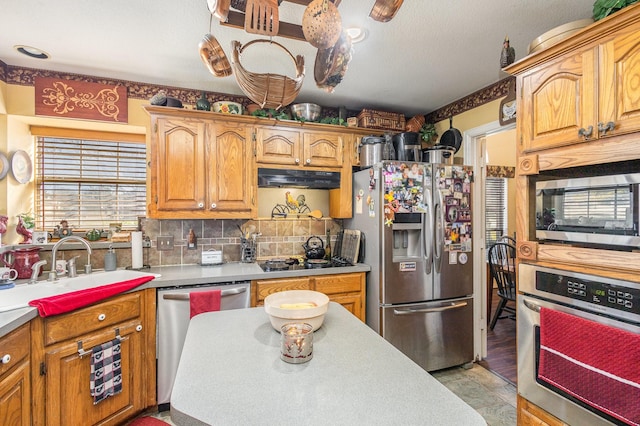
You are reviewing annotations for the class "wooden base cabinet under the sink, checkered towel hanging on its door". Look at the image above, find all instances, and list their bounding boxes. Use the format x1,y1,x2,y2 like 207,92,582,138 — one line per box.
31,289,156,426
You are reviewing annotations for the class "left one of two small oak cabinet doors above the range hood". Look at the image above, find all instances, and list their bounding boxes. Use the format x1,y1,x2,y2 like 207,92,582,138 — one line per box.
256,127,301,166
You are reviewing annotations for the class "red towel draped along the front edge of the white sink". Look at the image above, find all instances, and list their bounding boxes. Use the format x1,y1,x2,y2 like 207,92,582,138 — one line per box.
29,275,155,317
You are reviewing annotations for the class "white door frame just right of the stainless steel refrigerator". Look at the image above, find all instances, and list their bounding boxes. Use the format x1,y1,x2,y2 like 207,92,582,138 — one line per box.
463,120,516,361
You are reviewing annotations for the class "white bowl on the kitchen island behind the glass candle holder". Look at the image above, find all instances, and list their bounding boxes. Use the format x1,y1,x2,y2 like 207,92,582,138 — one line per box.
264,290,329,332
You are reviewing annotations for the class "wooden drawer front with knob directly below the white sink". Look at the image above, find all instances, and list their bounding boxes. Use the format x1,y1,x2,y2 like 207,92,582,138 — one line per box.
44,292,142,345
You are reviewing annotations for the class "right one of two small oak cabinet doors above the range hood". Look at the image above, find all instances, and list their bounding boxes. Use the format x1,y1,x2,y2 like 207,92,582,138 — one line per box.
302,132,344,167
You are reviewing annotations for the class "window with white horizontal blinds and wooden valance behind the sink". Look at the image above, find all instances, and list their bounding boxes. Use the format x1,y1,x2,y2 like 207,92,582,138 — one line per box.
32,128,146,229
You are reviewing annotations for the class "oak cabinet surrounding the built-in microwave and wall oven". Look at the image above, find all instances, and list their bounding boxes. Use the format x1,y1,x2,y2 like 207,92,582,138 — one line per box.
507,6,640,426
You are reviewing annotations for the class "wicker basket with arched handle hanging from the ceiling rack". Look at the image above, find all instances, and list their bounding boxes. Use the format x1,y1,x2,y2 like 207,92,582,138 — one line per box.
231,39,304,109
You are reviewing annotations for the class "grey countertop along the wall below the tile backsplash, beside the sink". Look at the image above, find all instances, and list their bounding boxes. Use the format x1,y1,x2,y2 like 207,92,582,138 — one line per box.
0,262,371,337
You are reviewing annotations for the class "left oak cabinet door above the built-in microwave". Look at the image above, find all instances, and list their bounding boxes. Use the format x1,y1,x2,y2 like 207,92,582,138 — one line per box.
518,49,597,151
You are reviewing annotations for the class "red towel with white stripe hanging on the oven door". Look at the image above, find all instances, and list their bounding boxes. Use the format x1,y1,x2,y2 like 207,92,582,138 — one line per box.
538,308,640,425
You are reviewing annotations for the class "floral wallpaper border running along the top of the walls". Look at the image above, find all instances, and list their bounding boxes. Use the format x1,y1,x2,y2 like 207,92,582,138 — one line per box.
0,61,515,118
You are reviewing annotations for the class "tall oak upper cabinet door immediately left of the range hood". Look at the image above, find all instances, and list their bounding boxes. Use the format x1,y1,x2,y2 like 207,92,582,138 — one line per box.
206,122,256,218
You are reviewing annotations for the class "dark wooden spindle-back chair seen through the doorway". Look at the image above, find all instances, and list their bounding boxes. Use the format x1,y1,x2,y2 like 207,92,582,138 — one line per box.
489,242,516,330
